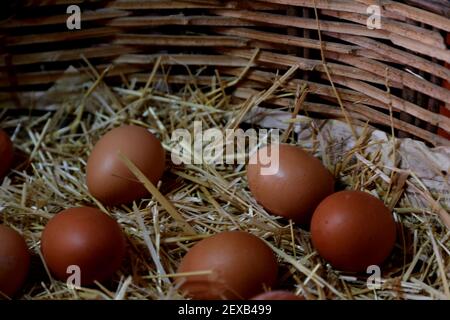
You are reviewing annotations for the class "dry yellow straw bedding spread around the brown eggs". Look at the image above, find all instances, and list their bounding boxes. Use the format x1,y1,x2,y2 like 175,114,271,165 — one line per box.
0,56,450,300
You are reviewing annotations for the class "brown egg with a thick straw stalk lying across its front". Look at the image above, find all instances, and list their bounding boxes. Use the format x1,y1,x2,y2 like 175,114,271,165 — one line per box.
86,126,165,205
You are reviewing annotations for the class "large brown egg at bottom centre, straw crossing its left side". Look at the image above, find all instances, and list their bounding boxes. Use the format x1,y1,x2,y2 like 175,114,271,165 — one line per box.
178,231,278,300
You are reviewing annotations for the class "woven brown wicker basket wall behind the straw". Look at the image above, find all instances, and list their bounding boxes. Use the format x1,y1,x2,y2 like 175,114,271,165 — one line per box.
0,0,450,145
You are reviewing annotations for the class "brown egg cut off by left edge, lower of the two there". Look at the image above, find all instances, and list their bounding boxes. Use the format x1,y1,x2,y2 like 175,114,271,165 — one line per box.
0,225,30,297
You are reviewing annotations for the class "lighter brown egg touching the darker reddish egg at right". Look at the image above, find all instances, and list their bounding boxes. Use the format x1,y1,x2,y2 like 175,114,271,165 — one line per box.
247,144,334,225
